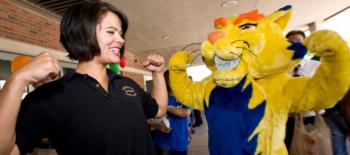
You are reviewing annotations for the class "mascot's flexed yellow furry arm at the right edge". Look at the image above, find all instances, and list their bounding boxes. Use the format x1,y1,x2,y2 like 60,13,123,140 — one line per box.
285,30,350,112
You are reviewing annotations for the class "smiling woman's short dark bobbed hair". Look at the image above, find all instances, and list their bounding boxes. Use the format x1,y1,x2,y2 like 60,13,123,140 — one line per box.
60,1,128,61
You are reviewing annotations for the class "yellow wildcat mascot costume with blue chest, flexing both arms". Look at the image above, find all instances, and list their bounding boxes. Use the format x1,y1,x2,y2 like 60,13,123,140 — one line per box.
169,6,350,155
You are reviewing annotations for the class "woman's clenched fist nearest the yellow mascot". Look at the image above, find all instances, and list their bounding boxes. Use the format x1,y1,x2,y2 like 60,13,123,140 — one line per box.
143,54,164,73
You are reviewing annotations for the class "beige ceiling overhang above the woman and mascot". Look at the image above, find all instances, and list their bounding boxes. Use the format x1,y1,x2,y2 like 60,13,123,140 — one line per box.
23,0,350,64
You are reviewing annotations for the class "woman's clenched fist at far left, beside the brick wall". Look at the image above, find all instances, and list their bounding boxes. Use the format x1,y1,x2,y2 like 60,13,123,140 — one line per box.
13,52,60,87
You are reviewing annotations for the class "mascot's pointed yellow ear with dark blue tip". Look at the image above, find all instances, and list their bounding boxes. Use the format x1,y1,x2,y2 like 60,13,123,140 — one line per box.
266,5,292,30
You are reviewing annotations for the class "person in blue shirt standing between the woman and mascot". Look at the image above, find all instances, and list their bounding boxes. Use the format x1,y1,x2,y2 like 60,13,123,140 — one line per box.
153,70,191,155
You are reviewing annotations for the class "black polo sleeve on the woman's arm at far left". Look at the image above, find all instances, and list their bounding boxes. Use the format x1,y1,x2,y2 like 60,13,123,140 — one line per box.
16,96,47,154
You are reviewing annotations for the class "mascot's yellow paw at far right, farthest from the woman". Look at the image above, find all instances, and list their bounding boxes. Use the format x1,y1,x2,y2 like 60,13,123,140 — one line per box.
304,30,346,57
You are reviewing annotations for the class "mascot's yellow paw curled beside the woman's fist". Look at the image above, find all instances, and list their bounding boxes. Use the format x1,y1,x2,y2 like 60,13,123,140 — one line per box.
169,51,193,69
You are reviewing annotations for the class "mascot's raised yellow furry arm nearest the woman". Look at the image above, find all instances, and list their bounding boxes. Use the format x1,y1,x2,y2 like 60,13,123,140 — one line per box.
169,51,212,110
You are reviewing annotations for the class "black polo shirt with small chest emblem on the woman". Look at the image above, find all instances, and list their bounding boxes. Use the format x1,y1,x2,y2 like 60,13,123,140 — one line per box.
16,70,158,155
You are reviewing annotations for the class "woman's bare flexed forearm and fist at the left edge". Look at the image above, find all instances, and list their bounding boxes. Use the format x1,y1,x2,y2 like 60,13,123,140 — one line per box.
0,53,60,154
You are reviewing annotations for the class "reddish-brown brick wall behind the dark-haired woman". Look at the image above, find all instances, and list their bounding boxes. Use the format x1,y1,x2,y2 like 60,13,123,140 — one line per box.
0,0,148,87
